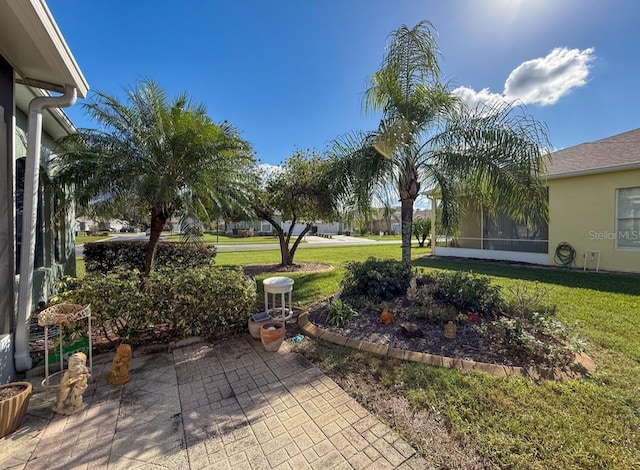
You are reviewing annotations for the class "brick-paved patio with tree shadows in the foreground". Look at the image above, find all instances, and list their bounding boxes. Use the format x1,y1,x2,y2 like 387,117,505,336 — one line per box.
0,336,430,470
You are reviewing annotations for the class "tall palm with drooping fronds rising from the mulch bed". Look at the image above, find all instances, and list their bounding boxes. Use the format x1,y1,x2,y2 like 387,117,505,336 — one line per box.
333,21,548,262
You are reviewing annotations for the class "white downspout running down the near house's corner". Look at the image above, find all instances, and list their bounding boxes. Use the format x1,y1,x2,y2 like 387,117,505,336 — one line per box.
13,85,77,372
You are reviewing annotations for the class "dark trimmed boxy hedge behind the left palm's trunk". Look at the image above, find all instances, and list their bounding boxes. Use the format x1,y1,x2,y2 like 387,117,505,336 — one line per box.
84,241,216,274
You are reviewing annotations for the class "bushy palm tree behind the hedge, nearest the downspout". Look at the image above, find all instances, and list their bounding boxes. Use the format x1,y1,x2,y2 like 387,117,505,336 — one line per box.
56,79,255,275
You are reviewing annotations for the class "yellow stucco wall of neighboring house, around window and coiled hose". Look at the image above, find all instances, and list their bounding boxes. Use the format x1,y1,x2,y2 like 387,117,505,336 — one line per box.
548,170,640,272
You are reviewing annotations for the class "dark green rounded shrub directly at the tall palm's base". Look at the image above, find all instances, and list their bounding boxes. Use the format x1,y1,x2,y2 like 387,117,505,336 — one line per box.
342,258,411,301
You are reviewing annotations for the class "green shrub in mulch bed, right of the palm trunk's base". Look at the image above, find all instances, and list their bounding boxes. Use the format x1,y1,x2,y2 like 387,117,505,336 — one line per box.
432,271,504,318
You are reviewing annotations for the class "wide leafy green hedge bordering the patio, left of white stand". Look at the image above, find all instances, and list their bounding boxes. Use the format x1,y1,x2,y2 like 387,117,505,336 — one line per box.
52,266,256,344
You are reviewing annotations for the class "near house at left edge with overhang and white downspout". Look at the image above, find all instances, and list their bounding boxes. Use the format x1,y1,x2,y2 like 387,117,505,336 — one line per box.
0,0,88,383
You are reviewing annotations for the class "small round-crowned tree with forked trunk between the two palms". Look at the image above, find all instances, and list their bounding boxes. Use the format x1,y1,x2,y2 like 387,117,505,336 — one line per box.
254,151,337,266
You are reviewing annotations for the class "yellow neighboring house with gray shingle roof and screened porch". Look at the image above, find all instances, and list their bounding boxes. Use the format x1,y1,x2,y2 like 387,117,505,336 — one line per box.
434,129,640,272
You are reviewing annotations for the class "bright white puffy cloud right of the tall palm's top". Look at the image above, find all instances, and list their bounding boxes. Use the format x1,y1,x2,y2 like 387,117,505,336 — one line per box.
453,47,594,108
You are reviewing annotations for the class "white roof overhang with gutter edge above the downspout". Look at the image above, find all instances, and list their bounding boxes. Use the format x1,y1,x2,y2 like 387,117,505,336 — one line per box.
0,0,89,98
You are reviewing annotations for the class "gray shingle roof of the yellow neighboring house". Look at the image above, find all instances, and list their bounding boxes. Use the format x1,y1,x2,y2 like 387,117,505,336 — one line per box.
547,129,640,177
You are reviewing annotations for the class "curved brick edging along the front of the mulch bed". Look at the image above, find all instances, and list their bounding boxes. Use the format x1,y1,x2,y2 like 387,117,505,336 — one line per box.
298,311,596,380
